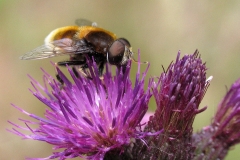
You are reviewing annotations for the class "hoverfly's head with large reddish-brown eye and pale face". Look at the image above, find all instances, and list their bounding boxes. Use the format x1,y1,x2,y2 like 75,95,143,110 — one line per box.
107,38,132,65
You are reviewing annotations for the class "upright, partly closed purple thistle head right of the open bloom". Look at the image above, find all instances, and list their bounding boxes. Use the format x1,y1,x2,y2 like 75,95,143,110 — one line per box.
137,50,209,160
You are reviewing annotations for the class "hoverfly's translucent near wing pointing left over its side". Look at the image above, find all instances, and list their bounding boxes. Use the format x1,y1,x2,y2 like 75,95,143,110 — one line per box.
19,38,90,60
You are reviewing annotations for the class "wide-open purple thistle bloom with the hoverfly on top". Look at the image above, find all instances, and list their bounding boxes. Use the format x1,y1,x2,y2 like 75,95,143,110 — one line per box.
10,54,152,159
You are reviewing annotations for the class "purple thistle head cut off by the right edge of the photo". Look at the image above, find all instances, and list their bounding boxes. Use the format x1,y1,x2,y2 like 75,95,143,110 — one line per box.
193,79,240,160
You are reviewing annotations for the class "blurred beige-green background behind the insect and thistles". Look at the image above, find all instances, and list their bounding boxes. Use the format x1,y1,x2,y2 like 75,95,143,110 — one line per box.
0,0,240,160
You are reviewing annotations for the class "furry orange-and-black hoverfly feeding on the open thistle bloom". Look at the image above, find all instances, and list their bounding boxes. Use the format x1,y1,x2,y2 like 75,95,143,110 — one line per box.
20,19,136,83
